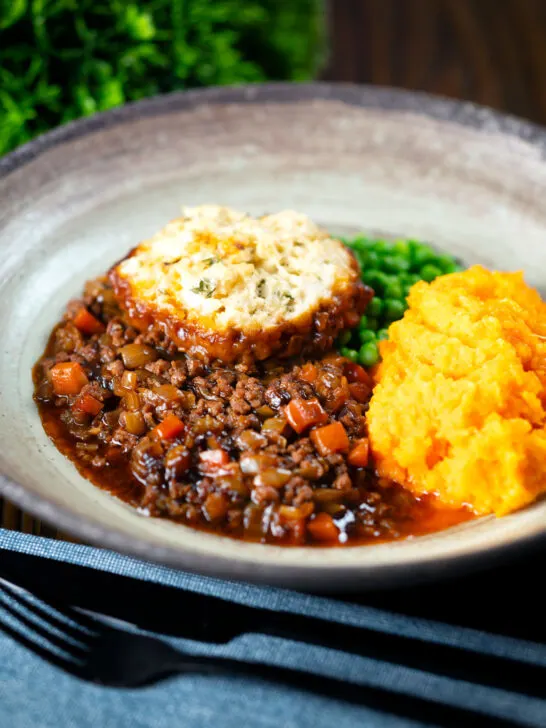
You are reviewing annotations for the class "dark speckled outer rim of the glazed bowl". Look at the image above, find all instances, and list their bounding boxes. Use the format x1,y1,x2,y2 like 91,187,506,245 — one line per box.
0,83,546,588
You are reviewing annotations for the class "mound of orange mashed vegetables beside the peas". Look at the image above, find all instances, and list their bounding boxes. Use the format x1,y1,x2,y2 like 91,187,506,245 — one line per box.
368,266,546,516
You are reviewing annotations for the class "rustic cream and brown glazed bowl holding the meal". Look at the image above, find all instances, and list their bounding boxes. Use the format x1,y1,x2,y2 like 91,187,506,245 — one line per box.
0,84,546,589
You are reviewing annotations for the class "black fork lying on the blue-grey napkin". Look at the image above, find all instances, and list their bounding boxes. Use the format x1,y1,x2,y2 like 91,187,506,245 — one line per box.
0,578,536,728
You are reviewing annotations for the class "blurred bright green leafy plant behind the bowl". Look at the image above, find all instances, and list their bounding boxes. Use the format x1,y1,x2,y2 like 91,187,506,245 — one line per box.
0,0,323,154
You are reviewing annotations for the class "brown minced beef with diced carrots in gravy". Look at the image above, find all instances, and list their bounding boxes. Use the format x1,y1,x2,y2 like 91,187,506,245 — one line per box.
34,279,464,545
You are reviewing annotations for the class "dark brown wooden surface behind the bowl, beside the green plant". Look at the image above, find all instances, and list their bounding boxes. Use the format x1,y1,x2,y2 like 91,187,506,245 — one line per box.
323,0,546,125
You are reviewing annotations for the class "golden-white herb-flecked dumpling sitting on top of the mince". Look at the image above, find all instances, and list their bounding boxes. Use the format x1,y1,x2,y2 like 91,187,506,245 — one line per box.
110,205,372,362
